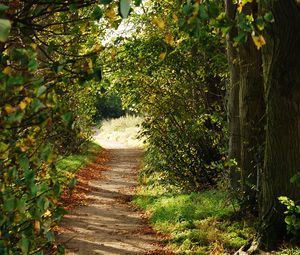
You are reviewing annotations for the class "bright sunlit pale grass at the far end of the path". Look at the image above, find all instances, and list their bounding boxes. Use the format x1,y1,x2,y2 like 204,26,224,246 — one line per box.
98,115,143,147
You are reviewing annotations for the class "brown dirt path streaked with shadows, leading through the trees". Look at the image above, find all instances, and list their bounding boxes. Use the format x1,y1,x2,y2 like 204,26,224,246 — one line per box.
59,140,167,255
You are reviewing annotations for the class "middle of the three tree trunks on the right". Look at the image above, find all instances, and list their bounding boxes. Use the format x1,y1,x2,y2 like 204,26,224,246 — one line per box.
239,1,265,209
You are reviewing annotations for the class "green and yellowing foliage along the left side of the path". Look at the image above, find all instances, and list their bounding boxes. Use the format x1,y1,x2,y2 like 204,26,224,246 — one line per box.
0,1,106,255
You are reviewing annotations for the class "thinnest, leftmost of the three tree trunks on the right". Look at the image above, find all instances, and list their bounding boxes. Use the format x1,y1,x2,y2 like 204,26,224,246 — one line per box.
225,0,241,190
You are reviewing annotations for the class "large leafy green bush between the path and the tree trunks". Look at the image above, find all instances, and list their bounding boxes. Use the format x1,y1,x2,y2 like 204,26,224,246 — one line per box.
104,1,226,190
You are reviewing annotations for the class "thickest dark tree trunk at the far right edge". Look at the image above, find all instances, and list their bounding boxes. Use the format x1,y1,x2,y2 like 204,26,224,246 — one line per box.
260,0,300,249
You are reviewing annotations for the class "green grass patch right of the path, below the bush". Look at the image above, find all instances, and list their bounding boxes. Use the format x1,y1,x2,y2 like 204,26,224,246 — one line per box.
134,172,255,255
